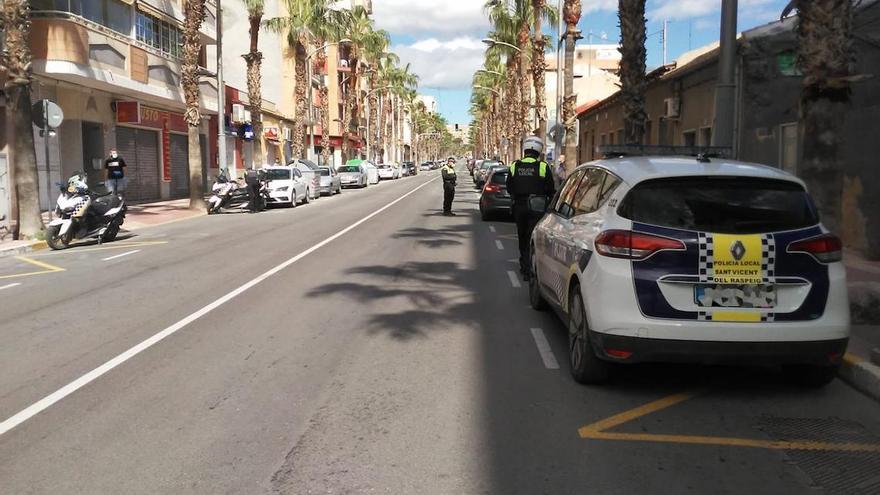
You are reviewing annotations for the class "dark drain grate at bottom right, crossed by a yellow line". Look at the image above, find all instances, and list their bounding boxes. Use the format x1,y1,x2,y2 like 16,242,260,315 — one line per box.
757,416,880,495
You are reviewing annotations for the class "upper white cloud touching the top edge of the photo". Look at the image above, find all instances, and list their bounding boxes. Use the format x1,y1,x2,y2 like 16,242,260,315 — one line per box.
373,0,489,37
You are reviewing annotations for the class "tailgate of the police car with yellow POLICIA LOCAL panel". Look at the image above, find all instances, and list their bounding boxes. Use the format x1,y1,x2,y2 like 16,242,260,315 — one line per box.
620,177,829,322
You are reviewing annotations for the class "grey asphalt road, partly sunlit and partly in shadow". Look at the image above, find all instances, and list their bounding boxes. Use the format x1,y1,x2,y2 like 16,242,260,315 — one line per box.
0,172,880,494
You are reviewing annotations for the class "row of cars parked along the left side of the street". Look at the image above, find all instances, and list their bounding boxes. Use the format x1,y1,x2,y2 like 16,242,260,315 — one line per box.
263,158,416,206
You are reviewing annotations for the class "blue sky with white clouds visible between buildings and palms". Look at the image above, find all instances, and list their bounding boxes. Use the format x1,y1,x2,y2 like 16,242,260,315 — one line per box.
373,0,788,124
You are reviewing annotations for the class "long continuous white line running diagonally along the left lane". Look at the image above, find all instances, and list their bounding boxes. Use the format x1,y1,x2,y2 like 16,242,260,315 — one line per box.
0,177,438,435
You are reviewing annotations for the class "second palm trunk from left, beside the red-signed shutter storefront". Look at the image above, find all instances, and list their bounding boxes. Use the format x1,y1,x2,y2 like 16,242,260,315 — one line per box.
180,0,207,209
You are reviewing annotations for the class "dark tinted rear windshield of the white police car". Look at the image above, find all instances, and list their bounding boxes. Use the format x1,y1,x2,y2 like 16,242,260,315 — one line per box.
618,177,819,234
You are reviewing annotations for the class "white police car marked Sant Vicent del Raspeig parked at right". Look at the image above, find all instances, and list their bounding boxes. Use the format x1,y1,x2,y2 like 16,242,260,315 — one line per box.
529,147,850,386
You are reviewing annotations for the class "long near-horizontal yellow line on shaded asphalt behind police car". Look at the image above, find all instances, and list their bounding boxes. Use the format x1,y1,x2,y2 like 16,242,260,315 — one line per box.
578,427,880,452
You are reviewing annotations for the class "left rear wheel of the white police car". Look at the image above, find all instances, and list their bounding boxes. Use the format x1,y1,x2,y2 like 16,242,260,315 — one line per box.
568,285,610,384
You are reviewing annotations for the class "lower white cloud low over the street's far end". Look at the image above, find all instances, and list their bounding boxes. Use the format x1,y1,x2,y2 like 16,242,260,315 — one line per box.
392,37,485,89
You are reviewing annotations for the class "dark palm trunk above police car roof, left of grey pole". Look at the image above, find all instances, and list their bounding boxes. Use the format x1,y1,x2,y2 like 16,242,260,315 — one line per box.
616,0,648,145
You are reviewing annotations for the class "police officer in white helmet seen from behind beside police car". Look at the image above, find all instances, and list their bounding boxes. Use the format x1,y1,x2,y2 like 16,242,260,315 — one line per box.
507,136,556,280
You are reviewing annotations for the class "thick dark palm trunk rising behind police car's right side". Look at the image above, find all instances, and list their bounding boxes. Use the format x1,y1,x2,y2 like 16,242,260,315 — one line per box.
783,0,854,230
